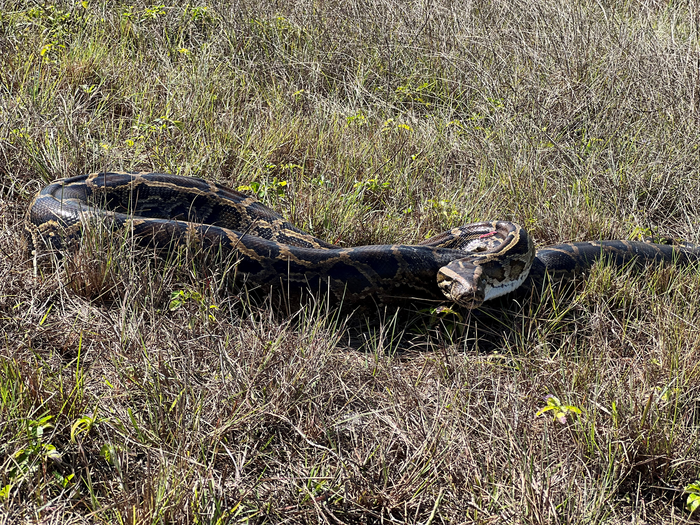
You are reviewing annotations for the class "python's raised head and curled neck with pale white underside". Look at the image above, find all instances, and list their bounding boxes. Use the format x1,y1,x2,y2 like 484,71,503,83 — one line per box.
437,221,535,309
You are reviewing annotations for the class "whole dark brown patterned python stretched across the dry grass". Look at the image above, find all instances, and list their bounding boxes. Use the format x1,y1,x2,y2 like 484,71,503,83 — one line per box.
26,172,700,308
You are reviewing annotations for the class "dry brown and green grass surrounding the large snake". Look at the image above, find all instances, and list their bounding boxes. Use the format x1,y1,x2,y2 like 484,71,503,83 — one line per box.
0,0,700,524
